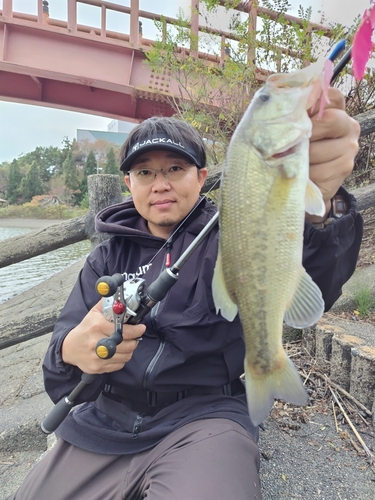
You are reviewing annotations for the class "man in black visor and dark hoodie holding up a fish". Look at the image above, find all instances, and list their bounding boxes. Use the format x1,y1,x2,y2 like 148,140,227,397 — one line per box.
6,89,362,500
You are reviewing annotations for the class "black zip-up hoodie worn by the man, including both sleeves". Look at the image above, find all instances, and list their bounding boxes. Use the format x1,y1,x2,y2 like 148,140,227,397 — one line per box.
43,193,362,454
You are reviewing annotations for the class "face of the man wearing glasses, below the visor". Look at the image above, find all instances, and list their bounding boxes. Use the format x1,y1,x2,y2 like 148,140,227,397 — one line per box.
125,151,207,238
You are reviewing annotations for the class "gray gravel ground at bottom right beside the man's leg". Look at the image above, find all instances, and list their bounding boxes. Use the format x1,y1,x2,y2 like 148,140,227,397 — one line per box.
259,411,375,500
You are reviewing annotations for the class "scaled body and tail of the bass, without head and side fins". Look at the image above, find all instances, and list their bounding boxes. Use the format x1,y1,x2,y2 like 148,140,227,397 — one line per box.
220,143,306,424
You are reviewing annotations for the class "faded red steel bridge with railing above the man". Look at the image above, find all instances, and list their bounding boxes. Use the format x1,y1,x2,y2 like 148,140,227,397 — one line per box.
0,0,323,121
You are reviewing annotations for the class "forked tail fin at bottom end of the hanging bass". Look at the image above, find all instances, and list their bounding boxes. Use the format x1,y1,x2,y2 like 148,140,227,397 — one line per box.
245,350,307,425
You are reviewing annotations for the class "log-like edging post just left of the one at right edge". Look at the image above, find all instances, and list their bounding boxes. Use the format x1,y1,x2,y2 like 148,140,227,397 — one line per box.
330,333,363,392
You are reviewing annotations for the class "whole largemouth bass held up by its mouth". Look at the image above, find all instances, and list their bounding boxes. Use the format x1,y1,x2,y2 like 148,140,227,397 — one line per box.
212,67,325,425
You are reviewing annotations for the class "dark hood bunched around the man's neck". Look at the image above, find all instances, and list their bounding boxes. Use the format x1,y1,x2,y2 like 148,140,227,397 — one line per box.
95,196,216,248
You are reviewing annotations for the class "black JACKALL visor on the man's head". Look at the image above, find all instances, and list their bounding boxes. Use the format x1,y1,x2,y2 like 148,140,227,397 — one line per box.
120,134,203,172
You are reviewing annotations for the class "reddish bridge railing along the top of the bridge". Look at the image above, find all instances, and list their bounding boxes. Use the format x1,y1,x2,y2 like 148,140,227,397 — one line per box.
0,0,330,70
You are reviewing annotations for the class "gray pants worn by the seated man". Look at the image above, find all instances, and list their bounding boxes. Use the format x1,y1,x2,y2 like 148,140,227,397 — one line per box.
8,419,262,500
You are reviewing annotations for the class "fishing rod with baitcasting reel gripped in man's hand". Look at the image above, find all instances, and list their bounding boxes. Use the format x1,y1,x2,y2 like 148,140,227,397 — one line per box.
41,212,219,434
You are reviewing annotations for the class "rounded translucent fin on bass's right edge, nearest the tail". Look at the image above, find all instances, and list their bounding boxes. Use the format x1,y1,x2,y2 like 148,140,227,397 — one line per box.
284,268,324,328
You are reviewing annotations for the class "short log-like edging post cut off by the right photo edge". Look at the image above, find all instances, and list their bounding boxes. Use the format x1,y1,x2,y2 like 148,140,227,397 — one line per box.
350,346,375,409
